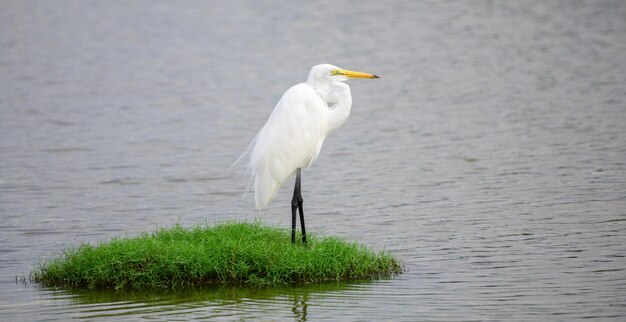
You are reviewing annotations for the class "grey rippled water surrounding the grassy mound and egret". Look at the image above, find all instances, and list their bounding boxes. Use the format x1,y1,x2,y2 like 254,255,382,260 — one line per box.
0,0,626,321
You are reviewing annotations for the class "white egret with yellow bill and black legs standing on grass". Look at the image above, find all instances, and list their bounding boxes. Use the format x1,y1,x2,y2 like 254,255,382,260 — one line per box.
240,64,378,243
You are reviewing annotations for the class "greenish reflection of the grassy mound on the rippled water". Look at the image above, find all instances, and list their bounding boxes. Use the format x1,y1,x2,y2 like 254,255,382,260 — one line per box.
42,283,360,321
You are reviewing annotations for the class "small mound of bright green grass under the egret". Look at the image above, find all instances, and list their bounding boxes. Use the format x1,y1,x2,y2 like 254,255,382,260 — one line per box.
31,222,401,290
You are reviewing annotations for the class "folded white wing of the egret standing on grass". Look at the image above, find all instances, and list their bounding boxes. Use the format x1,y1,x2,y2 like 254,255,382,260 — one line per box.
249,84,328,209
